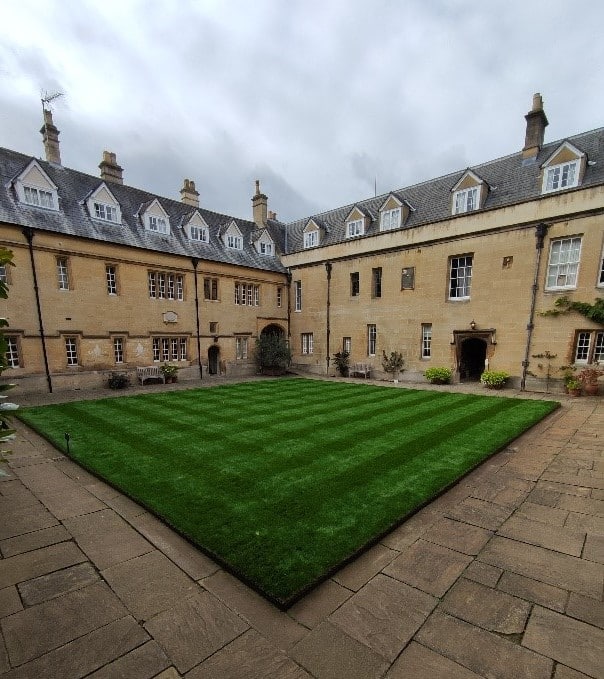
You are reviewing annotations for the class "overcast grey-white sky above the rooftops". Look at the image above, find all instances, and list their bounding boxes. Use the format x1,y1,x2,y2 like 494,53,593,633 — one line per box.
0,0,604,221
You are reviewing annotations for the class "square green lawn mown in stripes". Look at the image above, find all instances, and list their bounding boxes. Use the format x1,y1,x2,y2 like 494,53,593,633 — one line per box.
19,378,558,607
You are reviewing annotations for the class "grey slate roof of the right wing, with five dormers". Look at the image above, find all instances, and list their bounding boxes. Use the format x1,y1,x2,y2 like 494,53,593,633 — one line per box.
286,128,604,253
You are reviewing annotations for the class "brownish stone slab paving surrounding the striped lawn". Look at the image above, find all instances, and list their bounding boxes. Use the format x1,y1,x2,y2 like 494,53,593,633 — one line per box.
0,380,604,679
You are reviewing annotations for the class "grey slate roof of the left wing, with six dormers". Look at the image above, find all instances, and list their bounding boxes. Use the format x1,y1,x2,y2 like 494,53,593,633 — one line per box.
0,148,285,272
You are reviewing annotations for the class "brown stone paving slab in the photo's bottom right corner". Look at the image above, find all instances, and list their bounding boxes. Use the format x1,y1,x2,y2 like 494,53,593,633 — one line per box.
522,606,604,679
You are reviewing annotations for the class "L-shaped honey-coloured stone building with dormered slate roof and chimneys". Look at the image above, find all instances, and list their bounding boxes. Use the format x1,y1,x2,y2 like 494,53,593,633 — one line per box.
0,94,604,389
